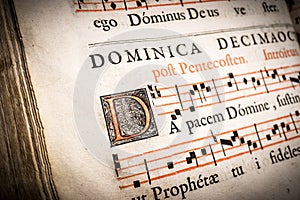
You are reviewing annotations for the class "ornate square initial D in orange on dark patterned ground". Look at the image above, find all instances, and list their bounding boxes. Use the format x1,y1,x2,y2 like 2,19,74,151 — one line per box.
101,89,158,146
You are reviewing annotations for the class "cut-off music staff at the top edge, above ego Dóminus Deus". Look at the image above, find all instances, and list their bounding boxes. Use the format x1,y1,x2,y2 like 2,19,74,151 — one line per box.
74,0,230,12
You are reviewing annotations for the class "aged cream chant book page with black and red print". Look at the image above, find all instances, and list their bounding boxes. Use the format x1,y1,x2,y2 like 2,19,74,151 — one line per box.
15,0,300,200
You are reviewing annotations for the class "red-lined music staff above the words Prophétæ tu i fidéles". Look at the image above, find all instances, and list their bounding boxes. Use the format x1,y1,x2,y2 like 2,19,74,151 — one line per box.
112,110,300,189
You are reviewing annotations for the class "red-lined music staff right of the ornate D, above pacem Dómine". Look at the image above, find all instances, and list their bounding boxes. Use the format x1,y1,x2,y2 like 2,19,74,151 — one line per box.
148,64,300,116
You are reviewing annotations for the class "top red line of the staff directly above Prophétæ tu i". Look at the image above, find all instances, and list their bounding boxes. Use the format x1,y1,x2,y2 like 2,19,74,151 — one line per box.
118,114,295,162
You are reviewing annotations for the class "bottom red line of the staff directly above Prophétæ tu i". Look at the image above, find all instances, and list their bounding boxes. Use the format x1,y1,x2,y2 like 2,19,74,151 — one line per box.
119,135,300,190
